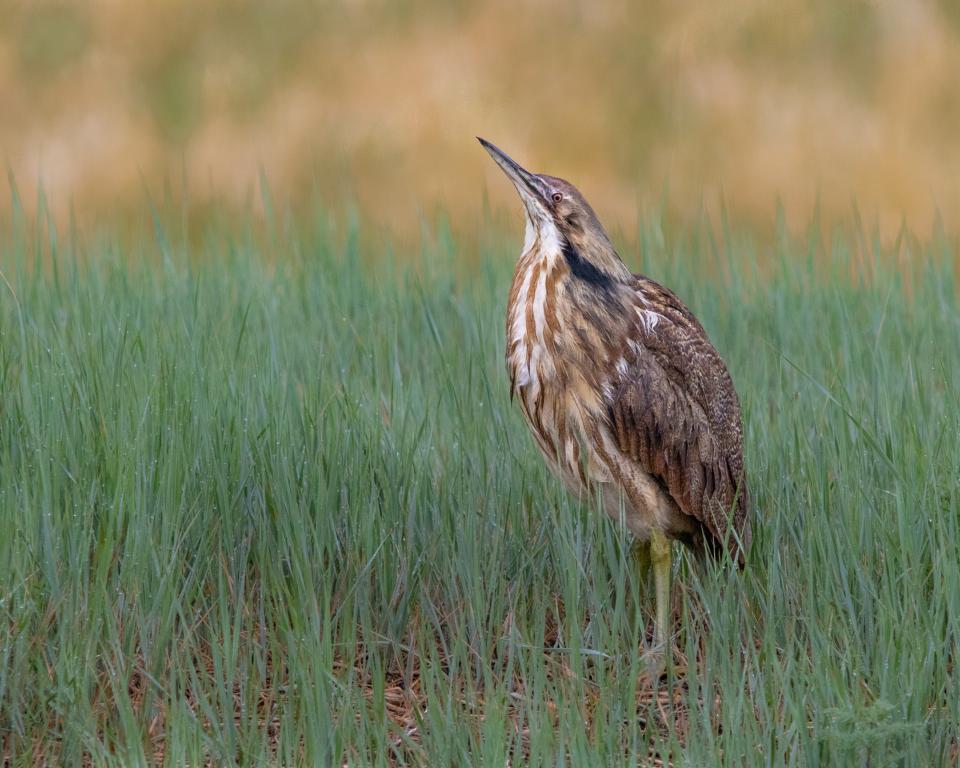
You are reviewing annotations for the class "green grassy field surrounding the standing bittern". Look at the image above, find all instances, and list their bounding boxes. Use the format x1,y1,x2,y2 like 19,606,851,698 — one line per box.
0,201,960,768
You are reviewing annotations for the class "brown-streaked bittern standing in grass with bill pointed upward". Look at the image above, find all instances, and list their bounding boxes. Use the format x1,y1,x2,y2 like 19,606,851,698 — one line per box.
478,137,751,645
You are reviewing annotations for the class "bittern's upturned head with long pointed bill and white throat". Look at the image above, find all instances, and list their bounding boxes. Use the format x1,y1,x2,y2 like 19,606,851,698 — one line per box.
477,136,630,280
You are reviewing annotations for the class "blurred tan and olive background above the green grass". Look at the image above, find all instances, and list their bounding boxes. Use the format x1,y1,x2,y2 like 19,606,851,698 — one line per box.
0,0,960,243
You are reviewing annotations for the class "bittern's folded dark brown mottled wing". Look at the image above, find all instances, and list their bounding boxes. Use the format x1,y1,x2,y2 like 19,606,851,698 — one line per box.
606,281,750,561
